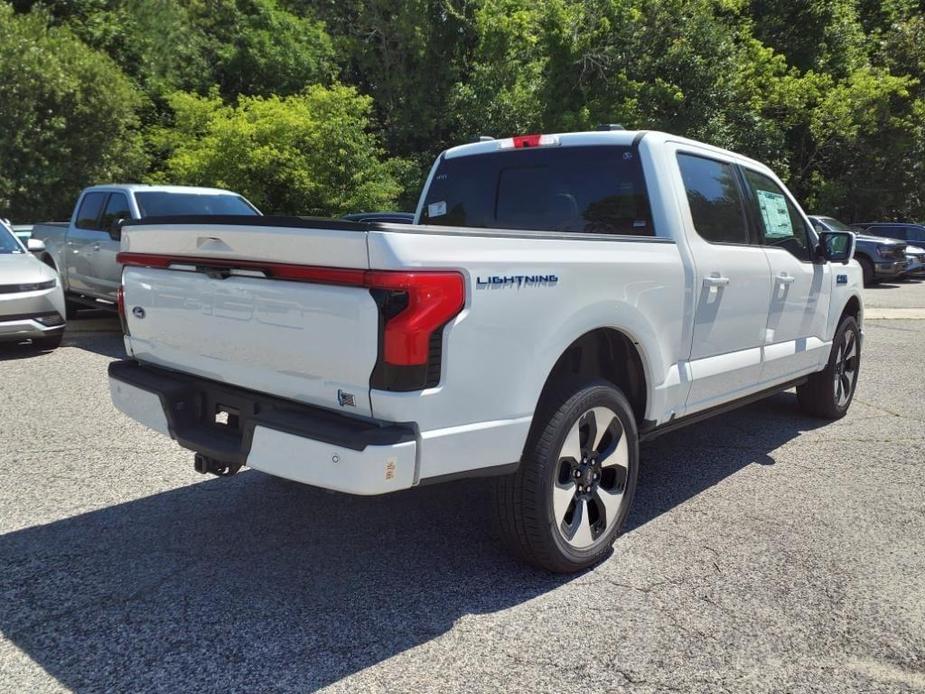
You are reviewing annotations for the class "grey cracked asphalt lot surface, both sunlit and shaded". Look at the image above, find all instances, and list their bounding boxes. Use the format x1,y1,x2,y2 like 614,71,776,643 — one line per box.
0,284,925,693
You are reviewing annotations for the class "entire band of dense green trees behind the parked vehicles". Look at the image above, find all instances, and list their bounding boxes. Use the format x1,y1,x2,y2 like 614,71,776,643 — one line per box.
0,0,925,221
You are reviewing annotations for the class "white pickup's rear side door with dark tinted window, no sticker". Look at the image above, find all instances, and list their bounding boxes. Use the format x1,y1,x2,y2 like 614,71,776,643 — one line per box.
675,145,771,412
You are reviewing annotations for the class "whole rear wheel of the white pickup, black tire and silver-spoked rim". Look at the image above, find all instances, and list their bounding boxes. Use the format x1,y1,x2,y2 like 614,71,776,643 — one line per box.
494,381,639,573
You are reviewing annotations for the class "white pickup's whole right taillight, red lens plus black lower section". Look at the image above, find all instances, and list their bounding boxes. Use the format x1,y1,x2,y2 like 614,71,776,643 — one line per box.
366,271,466,391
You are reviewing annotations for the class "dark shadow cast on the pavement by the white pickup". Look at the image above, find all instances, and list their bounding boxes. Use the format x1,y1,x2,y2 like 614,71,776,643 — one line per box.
0,394,817,691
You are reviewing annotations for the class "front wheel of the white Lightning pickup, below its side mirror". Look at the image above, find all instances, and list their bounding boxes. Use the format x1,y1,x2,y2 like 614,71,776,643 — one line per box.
797,316,861,419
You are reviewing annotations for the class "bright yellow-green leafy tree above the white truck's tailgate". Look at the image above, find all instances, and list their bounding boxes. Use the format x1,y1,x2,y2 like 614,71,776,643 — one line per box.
151,85,406,215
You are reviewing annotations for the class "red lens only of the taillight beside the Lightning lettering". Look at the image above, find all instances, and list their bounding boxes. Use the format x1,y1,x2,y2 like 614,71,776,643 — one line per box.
366,271,466,366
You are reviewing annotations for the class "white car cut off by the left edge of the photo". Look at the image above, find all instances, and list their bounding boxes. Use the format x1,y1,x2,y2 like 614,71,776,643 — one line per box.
0,220,65,349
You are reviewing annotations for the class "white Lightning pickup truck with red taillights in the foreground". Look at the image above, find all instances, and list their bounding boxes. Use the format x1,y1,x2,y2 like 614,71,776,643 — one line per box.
109,131,862,572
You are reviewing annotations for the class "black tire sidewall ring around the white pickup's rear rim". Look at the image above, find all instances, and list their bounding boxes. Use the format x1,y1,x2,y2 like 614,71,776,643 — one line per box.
539,382,639,566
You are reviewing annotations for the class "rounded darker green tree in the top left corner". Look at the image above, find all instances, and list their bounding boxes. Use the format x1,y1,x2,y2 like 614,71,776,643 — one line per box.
0,3,145,221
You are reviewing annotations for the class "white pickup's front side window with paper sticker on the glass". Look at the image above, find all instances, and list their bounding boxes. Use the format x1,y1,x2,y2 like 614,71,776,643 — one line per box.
743,169,813,262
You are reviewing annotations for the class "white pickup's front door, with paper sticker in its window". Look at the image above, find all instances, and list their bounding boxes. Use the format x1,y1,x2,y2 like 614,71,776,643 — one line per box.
741,167,832,382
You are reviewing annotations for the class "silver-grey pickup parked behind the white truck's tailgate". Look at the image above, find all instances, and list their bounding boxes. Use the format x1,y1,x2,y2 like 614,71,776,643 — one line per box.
32,184,260,318
